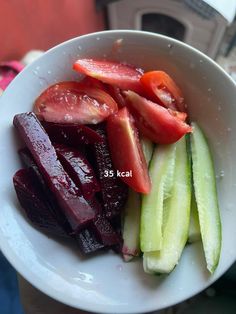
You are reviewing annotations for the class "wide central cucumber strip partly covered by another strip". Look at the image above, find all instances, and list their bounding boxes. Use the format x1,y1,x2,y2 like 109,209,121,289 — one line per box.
143,137,191,273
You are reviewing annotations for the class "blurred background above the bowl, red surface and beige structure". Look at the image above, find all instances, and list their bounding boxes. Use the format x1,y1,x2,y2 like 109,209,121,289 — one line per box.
0,0,236,73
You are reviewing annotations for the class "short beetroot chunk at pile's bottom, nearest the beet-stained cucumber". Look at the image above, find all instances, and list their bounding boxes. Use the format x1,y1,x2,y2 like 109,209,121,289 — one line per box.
93,215,121,246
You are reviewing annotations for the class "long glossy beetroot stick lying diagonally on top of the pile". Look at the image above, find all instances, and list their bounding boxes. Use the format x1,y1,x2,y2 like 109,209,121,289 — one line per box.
14,112,96,231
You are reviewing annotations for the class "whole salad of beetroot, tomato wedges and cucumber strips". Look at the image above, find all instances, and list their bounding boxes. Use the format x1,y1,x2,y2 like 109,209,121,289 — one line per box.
13,59,221,274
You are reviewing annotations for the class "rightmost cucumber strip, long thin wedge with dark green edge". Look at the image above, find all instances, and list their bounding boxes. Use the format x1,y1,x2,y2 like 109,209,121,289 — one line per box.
190,123,221,273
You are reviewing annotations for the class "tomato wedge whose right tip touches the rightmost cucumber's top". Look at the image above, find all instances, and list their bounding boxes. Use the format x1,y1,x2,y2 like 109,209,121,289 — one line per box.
125,91,192,144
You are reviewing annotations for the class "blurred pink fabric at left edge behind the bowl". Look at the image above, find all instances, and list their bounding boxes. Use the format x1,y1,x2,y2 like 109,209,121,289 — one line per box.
0,61,24,91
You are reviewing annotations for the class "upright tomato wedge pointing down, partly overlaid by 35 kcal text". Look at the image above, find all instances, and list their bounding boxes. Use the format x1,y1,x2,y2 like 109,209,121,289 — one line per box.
107,108,151,194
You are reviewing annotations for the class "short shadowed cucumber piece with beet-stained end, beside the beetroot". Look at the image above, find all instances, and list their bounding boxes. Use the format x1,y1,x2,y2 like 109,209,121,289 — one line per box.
122,189,141,262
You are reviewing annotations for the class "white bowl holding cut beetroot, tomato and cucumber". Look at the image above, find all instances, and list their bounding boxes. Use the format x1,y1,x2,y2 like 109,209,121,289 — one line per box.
0,31,236,313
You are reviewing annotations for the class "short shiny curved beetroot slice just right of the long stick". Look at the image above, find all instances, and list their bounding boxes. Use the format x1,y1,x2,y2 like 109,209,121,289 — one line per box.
55,145,100,200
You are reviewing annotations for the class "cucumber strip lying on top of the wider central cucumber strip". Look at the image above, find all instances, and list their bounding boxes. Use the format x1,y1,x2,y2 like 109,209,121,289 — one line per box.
140,144,176,252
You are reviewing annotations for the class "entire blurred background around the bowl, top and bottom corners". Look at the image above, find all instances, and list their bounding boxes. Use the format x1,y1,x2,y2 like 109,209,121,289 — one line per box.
0,0,236,314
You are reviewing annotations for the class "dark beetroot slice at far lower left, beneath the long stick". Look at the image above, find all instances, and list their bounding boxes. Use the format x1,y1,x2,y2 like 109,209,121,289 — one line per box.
13,169,68,237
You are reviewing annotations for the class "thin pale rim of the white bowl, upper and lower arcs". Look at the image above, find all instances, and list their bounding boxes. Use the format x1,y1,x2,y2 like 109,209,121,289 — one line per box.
0,29,236,314
